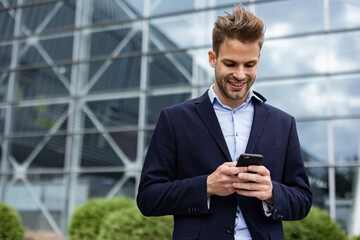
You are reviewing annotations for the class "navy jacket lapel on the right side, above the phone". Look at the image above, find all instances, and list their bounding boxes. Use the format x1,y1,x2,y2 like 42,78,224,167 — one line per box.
245,100,269,153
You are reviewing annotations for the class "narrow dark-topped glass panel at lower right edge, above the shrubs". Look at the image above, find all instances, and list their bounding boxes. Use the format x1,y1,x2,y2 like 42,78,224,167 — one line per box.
335,167,360,229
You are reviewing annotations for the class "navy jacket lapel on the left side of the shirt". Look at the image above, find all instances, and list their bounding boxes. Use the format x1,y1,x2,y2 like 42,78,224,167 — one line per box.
195,91,231,161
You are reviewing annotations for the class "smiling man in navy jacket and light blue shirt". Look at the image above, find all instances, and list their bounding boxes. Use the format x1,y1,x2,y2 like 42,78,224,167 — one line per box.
137,5,312,240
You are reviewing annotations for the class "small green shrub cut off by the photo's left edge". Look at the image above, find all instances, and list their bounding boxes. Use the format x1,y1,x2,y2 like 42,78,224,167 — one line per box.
0,202,24,240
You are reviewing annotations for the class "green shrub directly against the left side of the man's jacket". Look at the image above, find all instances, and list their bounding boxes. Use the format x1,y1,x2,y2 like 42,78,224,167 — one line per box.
97,207,173,240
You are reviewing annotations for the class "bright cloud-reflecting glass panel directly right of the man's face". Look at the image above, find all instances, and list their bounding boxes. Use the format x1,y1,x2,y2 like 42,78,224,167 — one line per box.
258,36,328,78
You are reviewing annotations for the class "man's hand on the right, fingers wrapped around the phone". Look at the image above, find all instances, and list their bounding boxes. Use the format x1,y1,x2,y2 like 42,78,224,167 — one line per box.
233,165,274,204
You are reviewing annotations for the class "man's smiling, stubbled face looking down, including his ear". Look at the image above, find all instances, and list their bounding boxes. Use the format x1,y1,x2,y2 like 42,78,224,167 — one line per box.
209,39,260,109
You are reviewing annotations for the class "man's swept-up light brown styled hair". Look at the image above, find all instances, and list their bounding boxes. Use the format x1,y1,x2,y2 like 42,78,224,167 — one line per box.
212,3,265,56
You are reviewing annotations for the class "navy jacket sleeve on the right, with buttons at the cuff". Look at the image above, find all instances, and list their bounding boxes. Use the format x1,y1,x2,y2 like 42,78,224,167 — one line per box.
272,118,312,221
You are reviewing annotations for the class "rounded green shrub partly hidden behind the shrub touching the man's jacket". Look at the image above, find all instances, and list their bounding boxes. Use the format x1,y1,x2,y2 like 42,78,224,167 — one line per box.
68,197,136,240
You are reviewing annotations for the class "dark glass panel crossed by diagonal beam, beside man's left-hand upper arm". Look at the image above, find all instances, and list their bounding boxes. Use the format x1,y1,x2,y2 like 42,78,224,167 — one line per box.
80,132,137,167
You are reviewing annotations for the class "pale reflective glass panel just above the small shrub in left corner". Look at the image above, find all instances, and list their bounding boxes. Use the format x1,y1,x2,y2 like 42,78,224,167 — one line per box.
5,174,65,231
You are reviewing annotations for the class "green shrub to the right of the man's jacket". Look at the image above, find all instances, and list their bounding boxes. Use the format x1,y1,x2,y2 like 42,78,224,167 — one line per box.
283,207,347,240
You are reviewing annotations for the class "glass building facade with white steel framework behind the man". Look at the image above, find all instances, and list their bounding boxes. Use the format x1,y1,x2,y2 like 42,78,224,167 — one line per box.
0,0,360,235
